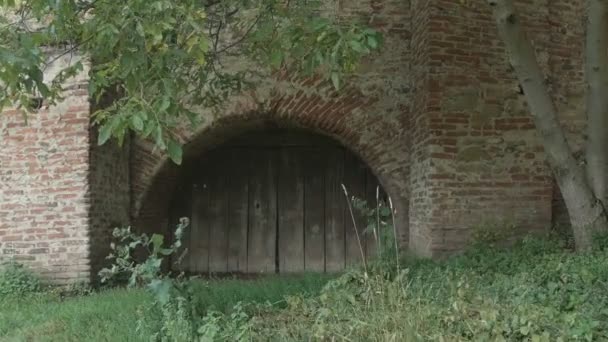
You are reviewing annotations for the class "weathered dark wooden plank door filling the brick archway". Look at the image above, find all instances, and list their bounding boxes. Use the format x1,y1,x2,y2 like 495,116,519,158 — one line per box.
173,131,378,273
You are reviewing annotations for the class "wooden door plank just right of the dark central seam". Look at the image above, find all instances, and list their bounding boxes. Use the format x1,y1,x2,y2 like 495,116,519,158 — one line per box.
277,147,306,273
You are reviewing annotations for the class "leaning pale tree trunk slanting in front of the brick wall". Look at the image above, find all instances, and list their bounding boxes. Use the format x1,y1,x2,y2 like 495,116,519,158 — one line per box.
487,0,608,250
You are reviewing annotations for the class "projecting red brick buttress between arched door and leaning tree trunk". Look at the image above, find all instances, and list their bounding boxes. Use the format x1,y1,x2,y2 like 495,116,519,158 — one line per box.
410,0,552,255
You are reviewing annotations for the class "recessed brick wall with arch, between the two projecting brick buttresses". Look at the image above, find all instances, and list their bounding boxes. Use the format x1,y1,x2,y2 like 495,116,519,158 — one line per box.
132,0,411,244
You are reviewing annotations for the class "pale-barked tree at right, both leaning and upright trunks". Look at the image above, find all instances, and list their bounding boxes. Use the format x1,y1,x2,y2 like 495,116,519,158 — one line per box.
487,0,608,250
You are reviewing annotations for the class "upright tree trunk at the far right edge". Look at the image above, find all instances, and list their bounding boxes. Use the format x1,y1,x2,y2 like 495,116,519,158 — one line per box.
585,0,608,208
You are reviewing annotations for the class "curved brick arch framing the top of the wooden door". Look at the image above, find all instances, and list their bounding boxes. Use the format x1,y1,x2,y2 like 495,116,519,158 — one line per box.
131,87,409,246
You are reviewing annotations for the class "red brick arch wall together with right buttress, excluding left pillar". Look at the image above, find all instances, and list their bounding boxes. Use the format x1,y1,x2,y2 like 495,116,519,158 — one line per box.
133,0,583,255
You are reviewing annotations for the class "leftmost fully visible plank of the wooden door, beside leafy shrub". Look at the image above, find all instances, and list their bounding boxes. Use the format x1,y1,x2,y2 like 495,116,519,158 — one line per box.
188,171,209,273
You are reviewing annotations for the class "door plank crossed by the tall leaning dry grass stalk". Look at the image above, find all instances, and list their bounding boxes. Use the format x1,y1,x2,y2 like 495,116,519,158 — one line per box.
344,153,365,266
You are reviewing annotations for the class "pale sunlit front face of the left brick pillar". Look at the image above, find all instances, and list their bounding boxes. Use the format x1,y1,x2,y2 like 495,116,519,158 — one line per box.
0,56,90,283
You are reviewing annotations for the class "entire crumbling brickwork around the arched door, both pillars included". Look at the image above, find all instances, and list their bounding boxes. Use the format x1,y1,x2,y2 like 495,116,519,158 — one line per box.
0,0,584,281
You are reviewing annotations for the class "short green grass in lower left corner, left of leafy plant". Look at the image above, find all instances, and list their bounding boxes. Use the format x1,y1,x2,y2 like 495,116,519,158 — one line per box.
0,289,151,341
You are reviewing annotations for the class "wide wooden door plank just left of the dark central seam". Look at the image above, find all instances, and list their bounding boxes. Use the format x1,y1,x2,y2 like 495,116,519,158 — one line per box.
247,149,277,273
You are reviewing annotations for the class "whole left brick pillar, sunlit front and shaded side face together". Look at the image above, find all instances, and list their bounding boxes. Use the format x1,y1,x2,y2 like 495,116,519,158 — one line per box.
0,56,131,284
